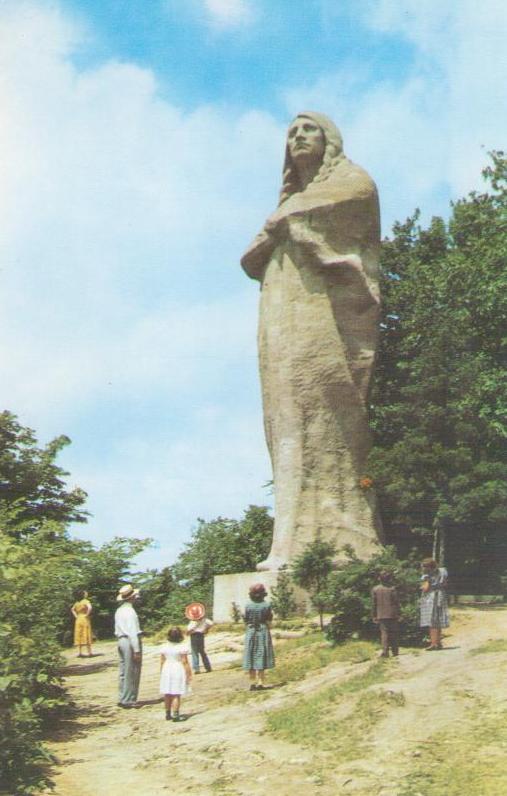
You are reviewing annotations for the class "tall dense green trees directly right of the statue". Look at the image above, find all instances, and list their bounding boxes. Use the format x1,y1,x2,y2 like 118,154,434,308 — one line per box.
370,152,507,583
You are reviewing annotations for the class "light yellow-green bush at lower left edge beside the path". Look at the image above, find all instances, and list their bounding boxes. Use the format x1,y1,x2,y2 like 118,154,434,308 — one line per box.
0,534,72,794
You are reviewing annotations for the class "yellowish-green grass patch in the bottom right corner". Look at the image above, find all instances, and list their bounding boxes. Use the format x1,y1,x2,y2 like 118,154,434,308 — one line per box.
398,701,507,796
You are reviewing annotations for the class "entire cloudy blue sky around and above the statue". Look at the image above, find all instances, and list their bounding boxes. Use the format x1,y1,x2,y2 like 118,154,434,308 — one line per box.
0,0,507,566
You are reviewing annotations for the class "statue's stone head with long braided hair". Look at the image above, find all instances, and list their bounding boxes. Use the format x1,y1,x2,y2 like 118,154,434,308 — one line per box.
280,111,343,202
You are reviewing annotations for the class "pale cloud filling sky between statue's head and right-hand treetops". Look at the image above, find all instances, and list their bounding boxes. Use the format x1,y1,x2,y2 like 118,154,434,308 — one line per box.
283,0,507,233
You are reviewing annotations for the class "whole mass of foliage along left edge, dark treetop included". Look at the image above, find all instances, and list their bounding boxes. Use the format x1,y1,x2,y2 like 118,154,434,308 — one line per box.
0,412,149,796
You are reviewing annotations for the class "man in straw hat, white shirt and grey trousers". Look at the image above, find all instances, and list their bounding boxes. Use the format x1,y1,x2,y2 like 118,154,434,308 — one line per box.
114,584,143,708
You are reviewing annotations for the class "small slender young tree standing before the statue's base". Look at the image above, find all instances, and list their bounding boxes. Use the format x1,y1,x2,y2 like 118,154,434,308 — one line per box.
292,536,336,630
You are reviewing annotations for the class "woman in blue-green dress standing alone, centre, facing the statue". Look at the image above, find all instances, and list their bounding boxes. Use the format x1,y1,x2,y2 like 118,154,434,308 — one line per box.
243,583,275,691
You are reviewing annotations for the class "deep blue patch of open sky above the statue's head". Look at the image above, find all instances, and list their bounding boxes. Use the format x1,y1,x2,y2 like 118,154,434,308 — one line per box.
64,0,413,112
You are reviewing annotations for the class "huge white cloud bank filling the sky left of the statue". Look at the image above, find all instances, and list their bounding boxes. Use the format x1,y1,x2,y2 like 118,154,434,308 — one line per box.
0,4,283,563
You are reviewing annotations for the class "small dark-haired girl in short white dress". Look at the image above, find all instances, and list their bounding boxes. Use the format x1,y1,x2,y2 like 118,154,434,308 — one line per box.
160,627,192,721
